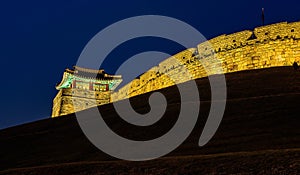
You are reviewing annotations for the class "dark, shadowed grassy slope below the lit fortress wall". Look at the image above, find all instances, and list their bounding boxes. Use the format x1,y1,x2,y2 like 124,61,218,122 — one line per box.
0,67,300,174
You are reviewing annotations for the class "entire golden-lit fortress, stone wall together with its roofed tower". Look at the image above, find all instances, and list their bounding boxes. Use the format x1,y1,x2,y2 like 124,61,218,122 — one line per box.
52,22,300,113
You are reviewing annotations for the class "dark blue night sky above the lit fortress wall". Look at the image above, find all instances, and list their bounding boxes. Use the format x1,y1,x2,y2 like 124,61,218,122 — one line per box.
0,0,300,128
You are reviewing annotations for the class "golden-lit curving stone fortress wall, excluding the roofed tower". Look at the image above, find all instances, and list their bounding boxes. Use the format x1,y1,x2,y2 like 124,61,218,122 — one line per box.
111,22,300,102
